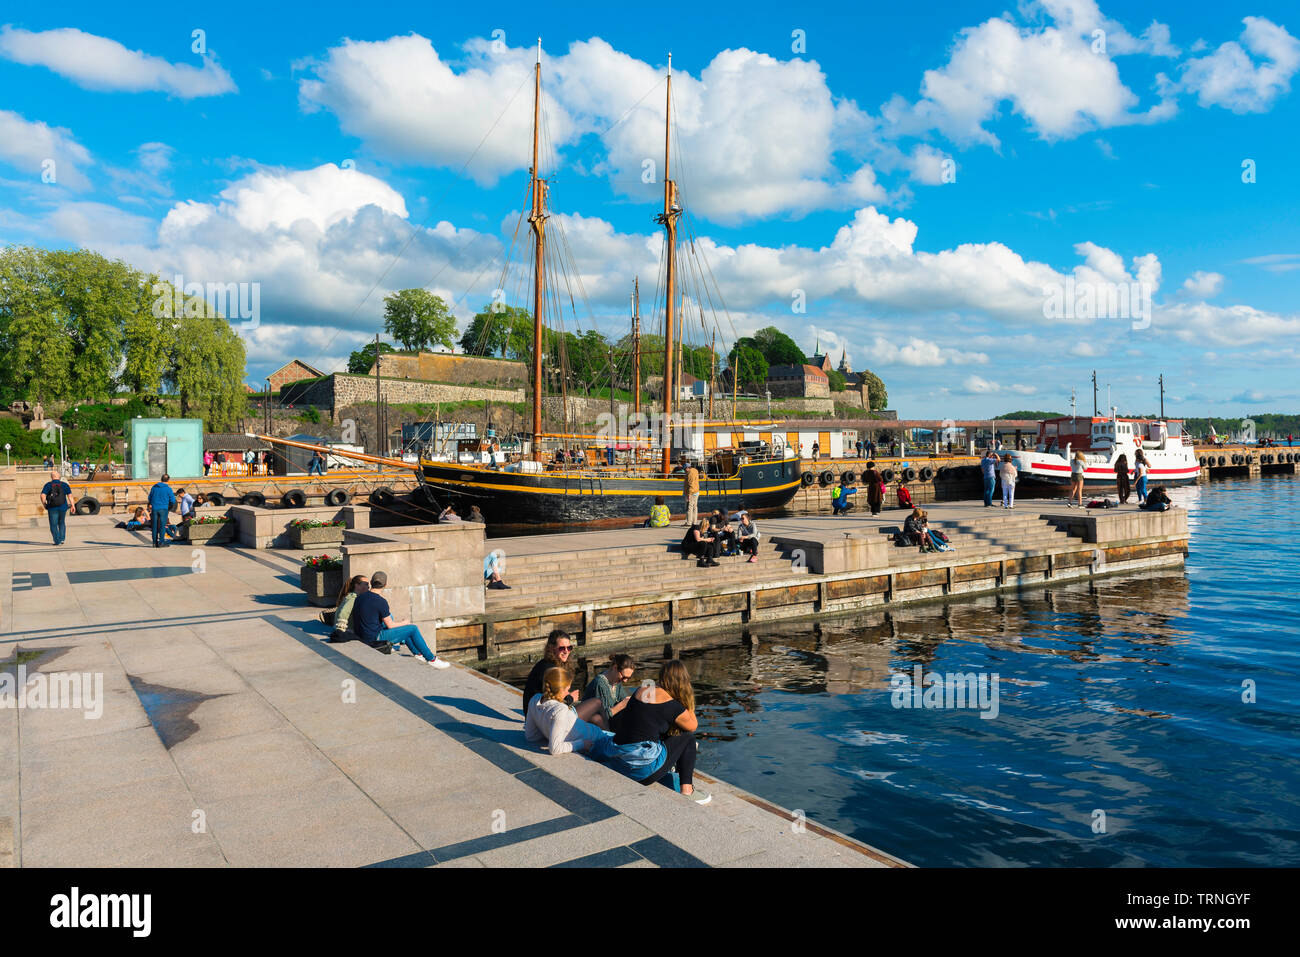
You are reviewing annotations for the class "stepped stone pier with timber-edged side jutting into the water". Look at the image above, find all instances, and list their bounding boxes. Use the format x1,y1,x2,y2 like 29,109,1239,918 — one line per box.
434,499,1188,661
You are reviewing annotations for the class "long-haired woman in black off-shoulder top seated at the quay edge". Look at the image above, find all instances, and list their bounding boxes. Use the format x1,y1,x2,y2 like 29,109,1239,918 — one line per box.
614,659,712,804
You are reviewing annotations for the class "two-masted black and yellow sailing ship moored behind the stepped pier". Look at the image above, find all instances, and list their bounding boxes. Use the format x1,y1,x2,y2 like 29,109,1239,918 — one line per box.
415,44,800,525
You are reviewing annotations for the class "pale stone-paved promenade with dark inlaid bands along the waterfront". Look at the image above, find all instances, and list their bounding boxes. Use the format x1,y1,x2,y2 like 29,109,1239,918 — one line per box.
0,515,897,867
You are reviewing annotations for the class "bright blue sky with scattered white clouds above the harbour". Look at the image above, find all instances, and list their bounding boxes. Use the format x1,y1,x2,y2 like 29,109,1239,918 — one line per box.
0,0,1300,419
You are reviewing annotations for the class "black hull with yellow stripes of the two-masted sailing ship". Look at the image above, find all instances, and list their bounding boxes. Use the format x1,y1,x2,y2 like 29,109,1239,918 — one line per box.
415,459,800,525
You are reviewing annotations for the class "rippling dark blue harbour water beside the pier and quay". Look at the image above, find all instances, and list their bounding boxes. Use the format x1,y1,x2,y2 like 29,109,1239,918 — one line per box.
488,476,1300,866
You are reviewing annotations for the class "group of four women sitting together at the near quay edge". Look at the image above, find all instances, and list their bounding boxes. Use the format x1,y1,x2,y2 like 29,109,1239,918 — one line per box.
524,629,712,804
